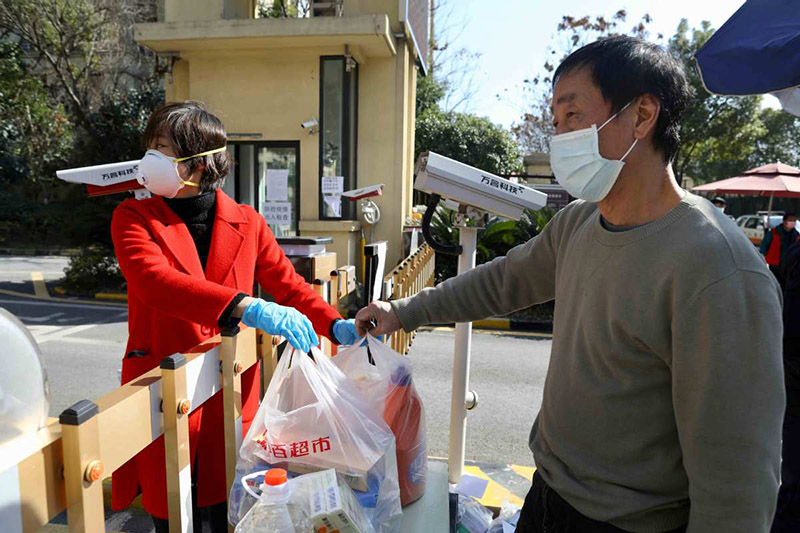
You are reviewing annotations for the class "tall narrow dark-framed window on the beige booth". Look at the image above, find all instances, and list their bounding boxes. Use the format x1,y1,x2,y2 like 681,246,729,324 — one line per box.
319,56,358,220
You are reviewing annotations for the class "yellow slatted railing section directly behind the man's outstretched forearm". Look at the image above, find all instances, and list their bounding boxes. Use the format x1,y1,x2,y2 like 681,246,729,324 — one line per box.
383,244,436,355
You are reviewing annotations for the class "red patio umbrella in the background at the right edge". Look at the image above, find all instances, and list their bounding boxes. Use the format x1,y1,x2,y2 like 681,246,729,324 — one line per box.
692,163,800,212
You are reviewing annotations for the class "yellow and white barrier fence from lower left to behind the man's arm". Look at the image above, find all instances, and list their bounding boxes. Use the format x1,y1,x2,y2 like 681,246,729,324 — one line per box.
0,252,433,533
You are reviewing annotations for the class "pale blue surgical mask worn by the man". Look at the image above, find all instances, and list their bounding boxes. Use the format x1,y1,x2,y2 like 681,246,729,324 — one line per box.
550,101,639,202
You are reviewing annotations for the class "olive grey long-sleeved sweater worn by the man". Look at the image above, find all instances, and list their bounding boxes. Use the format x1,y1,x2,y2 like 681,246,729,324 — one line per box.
392,194,785,533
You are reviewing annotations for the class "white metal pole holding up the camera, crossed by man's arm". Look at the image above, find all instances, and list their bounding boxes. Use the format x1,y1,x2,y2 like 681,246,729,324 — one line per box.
448,226,478,483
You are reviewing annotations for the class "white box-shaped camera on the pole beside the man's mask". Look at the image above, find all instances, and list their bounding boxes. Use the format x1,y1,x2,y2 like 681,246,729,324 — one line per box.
414,152,547,220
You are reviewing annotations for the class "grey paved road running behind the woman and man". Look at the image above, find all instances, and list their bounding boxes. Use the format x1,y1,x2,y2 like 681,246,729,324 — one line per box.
0,257,551,465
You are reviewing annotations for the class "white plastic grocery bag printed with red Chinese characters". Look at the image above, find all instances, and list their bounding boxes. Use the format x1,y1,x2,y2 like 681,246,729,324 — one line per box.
228,348,402,533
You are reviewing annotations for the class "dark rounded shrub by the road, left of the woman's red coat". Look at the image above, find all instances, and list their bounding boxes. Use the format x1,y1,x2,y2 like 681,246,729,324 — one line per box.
61,246,126,296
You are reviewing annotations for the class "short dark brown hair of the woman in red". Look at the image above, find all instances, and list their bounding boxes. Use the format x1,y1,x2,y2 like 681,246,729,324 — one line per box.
142,100,231,192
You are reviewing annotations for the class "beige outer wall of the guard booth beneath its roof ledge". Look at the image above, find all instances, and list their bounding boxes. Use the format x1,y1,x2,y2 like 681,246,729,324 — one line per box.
161,41,416,266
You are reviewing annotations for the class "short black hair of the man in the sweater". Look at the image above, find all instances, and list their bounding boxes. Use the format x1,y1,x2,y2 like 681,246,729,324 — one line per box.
553,36,692,163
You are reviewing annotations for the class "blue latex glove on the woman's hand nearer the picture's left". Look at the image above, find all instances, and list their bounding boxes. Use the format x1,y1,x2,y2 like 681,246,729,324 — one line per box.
242,298,319,353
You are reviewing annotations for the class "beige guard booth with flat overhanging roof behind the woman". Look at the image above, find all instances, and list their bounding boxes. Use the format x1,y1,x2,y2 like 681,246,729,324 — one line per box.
135,0,429,272
